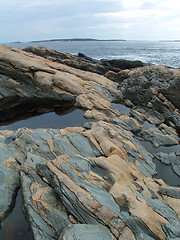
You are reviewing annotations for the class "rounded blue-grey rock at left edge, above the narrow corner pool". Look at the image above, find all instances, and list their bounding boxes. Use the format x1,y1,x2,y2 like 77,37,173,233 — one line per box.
0,131,21,222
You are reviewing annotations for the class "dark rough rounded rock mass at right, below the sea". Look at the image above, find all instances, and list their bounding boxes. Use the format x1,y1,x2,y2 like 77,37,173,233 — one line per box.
119,66,180,128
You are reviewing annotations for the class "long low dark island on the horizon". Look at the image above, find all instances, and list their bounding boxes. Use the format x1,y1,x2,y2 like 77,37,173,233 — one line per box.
31,38,127,43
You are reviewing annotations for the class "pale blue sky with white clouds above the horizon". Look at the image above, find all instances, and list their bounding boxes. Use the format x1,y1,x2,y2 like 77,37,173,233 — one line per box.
0,0,180,43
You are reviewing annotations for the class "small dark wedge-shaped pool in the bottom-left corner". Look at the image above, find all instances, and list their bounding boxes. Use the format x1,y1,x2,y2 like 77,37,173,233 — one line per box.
0,190,32,240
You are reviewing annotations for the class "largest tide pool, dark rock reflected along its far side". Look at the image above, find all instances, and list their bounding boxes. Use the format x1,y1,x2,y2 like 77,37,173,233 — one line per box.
0,99,87,130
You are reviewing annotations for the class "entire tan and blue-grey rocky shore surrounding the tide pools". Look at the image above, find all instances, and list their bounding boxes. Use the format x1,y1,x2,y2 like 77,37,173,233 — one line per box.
0,45,180,240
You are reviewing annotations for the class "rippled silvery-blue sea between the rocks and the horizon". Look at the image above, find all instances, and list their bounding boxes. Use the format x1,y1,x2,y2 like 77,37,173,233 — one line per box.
5,41,180,68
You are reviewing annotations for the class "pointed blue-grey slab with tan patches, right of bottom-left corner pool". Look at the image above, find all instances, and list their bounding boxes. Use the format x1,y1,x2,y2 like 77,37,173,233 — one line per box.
21,165,71,240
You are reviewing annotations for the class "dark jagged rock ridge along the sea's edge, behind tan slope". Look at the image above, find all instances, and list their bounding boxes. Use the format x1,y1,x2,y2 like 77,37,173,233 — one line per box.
24,46,145,75
